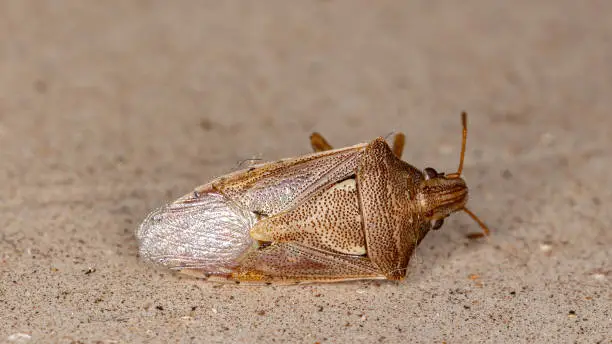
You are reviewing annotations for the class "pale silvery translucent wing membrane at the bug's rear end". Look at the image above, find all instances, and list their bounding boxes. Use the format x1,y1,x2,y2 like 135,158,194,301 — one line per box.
136,193,256,274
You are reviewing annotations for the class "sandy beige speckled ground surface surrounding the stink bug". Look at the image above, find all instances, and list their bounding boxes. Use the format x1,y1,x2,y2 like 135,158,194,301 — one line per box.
0,0,612,343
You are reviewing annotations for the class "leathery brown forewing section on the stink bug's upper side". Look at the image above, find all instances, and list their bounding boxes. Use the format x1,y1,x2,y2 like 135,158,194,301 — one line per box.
213,144,366,216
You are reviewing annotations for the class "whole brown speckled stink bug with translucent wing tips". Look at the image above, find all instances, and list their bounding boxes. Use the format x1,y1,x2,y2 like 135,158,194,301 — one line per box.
136,113,488,283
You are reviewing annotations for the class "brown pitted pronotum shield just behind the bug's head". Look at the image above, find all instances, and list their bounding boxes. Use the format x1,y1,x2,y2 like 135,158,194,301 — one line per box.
357,138,430,279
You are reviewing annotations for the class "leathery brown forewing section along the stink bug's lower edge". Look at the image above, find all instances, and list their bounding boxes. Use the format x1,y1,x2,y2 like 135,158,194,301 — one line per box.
233,243,385,283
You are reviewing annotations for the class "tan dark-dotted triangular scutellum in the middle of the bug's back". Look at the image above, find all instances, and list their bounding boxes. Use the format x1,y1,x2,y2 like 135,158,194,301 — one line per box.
251,179,366,255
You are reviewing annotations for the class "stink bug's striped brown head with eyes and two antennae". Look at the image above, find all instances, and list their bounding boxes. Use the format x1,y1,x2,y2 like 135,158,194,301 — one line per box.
417,112,489,235
